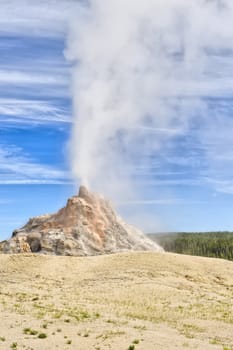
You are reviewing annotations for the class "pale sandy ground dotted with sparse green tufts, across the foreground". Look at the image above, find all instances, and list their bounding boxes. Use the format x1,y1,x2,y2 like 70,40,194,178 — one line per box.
0,253,233,350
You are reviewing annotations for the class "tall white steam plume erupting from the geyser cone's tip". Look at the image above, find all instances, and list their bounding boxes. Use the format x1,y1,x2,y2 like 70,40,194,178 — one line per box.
66,0,233,199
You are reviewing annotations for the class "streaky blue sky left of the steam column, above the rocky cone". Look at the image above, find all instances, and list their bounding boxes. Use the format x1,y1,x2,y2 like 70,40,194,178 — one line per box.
0,1,76,239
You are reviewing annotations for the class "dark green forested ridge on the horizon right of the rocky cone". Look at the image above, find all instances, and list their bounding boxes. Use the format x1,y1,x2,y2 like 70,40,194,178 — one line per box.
149,231,233,260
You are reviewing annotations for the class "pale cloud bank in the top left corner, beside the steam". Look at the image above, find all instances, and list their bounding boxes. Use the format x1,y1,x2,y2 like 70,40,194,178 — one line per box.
0,0,79,37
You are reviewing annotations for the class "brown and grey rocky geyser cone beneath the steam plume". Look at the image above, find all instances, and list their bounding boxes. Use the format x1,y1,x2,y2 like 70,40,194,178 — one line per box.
0,186,162,256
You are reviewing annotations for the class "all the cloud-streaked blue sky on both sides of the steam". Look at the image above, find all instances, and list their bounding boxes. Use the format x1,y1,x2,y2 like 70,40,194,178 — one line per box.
0,0,233,239
